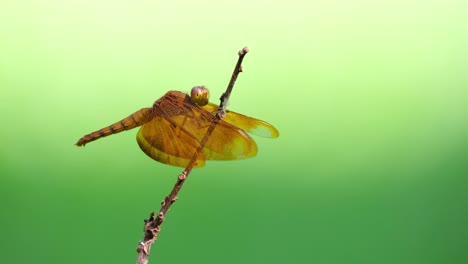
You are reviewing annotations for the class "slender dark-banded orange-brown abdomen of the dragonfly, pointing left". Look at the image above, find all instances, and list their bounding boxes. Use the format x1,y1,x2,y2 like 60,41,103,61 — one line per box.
76,107,153,146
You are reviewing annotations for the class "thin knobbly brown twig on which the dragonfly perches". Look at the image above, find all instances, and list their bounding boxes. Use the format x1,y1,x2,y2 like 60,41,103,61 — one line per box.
137,47,249,264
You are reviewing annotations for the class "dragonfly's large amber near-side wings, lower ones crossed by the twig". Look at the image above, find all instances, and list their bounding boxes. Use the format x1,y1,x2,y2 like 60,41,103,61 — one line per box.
137,93,257,167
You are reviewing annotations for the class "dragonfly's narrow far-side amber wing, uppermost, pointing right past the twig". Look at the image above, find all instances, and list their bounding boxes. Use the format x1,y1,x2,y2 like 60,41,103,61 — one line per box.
202,103,279,138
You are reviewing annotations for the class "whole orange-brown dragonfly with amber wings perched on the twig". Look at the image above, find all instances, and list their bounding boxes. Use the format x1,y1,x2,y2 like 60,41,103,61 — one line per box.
76,86,279,168
